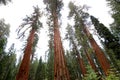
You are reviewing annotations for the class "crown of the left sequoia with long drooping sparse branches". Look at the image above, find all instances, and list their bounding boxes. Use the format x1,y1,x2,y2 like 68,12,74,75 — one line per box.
17,6,43,38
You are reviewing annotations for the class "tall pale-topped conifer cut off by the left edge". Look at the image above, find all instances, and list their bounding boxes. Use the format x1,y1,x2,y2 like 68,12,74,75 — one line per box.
0,19,12,80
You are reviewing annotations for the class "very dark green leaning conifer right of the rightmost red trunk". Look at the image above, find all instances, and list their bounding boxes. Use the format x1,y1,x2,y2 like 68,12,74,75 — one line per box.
91,16,120,71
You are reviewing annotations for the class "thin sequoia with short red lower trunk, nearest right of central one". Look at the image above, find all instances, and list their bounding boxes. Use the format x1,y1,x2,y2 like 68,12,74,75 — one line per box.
66,25,86,76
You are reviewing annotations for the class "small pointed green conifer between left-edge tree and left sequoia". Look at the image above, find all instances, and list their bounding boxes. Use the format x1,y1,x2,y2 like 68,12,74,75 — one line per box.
3,44,16,80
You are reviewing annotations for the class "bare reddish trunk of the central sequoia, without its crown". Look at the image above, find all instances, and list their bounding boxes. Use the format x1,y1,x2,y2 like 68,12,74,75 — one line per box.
52,10,70,80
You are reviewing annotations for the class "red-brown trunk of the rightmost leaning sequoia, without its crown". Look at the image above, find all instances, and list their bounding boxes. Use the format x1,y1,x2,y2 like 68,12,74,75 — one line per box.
84,26,110,75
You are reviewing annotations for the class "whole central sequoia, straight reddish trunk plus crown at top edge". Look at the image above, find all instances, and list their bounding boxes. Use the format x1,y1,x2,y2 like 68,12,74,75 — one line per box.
44,0,70,80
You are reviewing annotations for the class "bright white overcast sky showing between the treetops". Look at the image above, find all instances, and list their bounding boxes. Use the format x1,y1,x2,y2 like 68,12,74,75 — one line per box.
0,0,113,58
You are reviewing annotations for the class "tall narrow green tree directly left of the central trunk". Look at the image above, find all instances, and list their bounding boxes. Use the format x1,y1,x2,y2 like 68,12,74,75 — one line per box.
46,13,54,80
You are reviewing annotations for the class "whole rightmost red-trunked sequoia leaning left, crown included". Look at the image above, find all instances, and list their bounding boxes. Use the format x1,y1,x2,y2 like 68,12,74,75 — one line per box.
69,3,110,75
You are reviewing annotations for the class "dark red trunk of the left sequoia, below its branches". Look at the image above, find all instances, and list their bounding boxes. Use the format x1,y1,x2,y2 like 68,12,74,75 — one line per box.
16,29,35,80
